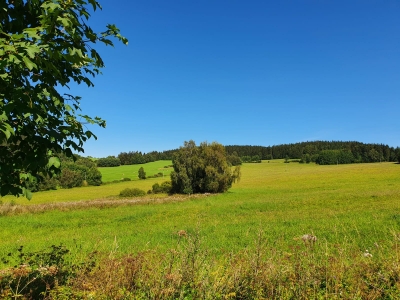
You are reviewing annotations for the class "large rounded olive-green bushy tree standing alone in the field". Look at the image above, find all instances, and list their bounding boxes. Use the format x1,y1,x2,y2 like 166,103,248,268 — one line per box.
171,141,240,194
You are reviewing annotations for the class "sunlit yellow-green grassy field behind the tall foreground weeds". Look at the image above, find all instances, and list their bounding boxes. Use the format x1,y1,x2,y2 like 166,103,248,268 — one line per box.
0,160,400,299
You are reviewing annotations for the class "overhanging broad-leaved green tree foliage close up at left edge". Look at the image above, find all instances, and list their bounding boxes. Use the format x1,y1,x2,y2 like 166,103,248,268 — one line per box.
0,0,127,198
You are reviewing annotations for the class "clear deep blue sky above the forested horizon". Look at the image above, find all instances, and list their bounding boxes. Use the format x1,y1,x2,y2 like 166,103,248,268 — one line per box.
71,0,400,157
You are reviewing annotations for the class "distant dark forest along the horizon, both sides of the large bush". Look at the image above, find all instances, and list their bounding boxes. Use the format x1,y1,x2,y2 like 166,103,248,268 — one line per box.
97,141,400,167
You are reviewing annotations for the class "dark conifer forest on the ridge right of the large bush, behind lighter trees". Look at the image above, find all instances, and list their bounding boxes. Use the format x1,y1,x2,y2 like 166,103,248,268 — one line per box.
225,141,400,162
